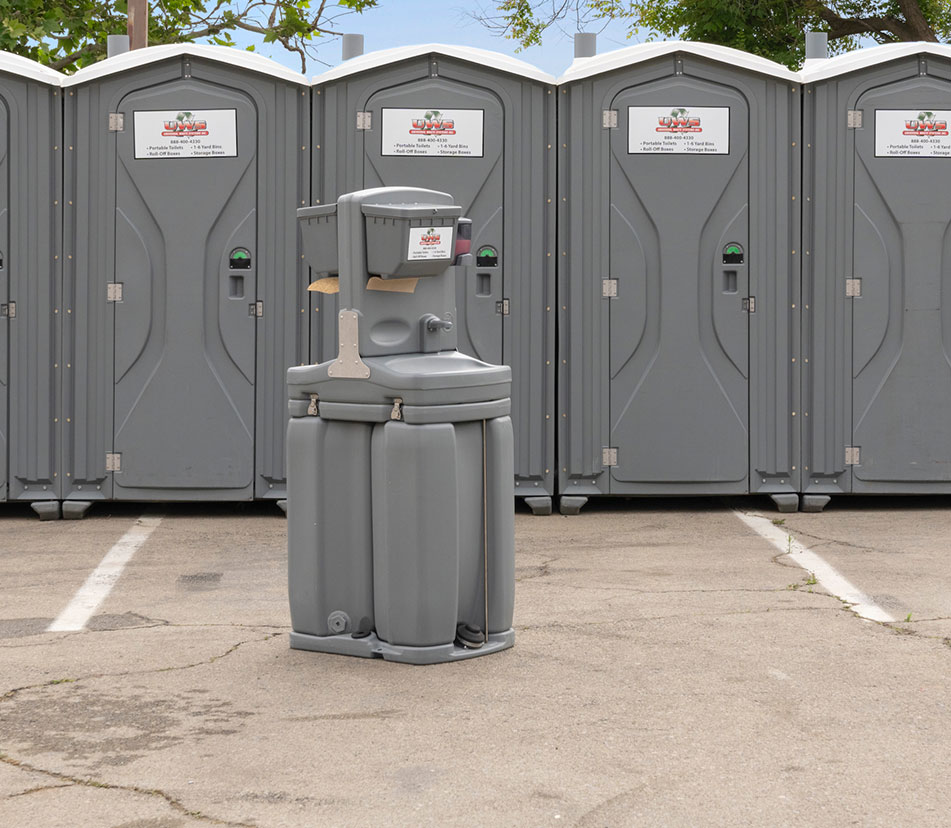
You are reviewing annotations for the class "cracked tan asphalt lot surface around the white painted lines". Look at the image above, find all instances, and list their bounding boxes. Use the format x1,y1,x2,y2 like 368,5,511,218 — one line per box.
0,498,951,828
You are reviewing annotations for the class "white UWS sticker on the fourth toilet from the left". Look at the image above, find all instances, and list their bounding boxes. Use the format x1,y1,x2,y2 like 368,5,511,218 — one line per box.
627,106,730,155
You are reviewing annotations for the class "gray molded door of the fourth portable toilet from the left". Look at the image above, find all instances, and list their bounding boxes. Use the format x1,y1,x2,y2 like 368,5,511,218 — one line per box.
607,77,750,493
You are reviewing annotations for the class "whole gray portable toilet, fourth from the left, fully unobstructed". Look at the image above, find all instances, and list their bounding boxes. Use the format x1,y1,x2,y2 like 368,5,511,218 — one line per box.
558,42,800,513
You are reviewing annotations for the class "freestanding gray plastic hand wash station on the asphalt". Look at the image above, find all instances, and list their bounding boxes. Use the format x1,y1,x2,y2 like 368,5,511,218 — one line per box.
287,187,515,664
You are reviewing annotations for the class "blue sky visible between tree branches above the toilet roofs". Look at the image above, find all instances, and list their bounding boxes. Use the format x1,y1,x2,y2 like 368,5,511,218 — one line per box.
235,0,637,76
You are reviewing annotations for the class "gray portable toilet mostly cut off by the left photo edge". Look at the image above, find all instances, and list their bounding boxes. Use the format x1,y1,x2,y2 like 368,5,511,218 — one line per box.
0,52,64,518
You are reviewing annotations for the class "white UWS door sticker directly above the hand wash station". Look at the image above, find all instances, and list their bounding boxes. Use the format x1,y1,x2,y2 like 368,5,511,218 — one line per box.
382,108,485,158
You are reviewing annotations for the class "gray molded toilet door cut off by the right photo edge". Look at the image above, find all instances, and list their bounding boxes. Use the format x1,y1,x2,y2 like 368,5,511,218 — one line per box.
852,78,951,493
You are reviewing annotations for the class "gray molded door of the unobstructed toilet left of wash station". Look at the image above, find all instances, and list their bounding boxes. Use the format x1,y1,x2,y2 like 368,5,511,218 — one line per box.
113,79,258,499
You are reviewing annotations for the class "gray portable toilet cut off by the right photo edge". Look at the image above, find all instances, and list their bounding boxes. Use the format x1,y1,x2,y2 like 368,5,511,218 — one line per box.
802,43,951,511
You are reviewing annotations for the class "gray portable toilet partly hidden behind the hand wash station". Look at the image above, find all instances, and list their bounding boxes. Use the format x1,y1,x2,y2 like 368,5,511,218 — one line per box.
310,44,556,513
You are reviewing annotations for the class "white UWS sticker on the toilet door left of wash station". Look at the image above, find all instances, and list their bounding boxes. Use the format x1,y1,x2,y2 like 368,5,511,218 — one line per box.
133,109,238,158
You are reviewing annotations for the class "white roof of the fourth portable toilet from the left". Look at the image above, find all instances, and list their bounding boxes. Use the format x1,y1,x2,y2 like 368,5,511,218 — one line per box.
558,40,800,84
